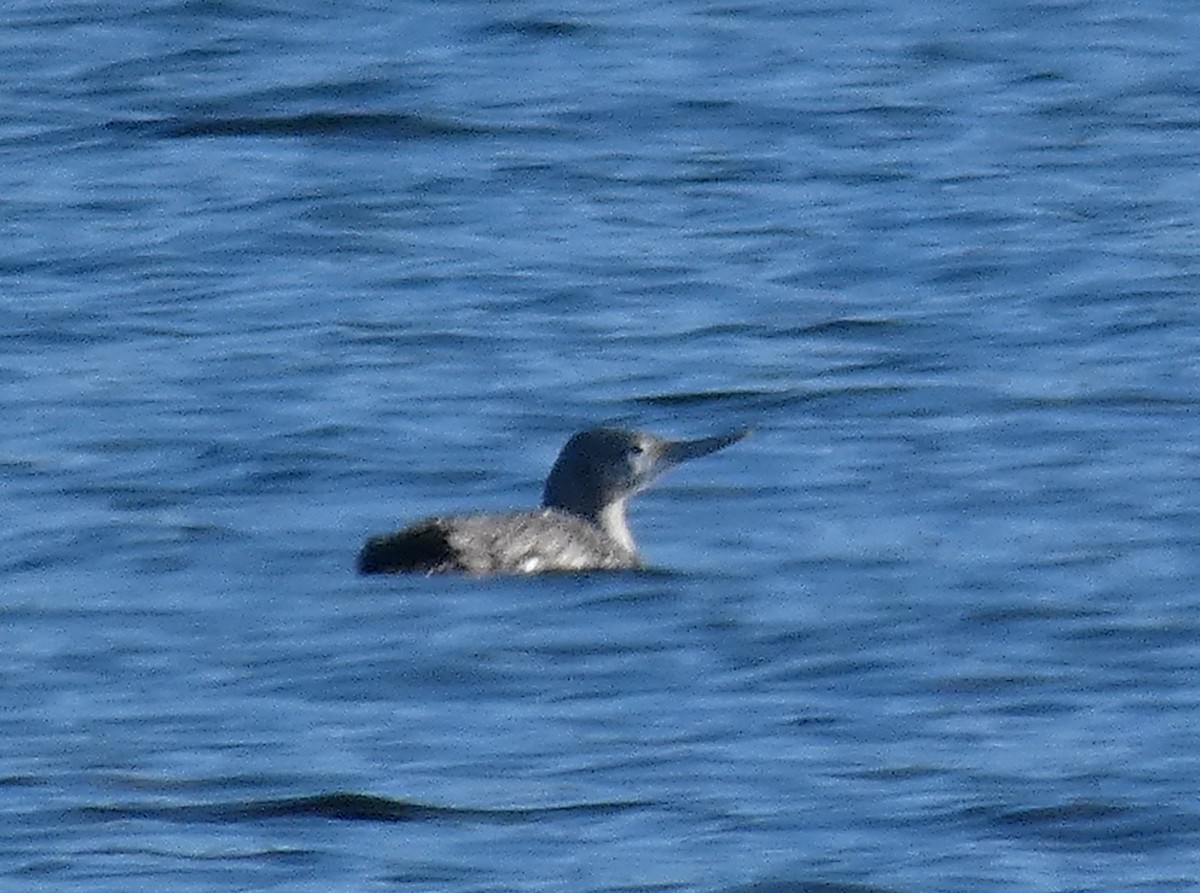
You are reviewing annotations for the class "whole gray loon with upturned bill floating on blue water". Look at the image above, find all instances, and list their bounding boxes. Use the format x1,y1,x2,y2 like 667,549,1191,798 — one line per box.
358,427,750,574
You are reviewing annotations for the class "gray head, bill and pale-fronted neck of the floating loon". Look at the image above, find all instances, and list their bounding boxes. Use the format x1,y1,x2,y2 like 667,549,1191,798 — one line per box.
541,428,750,553
